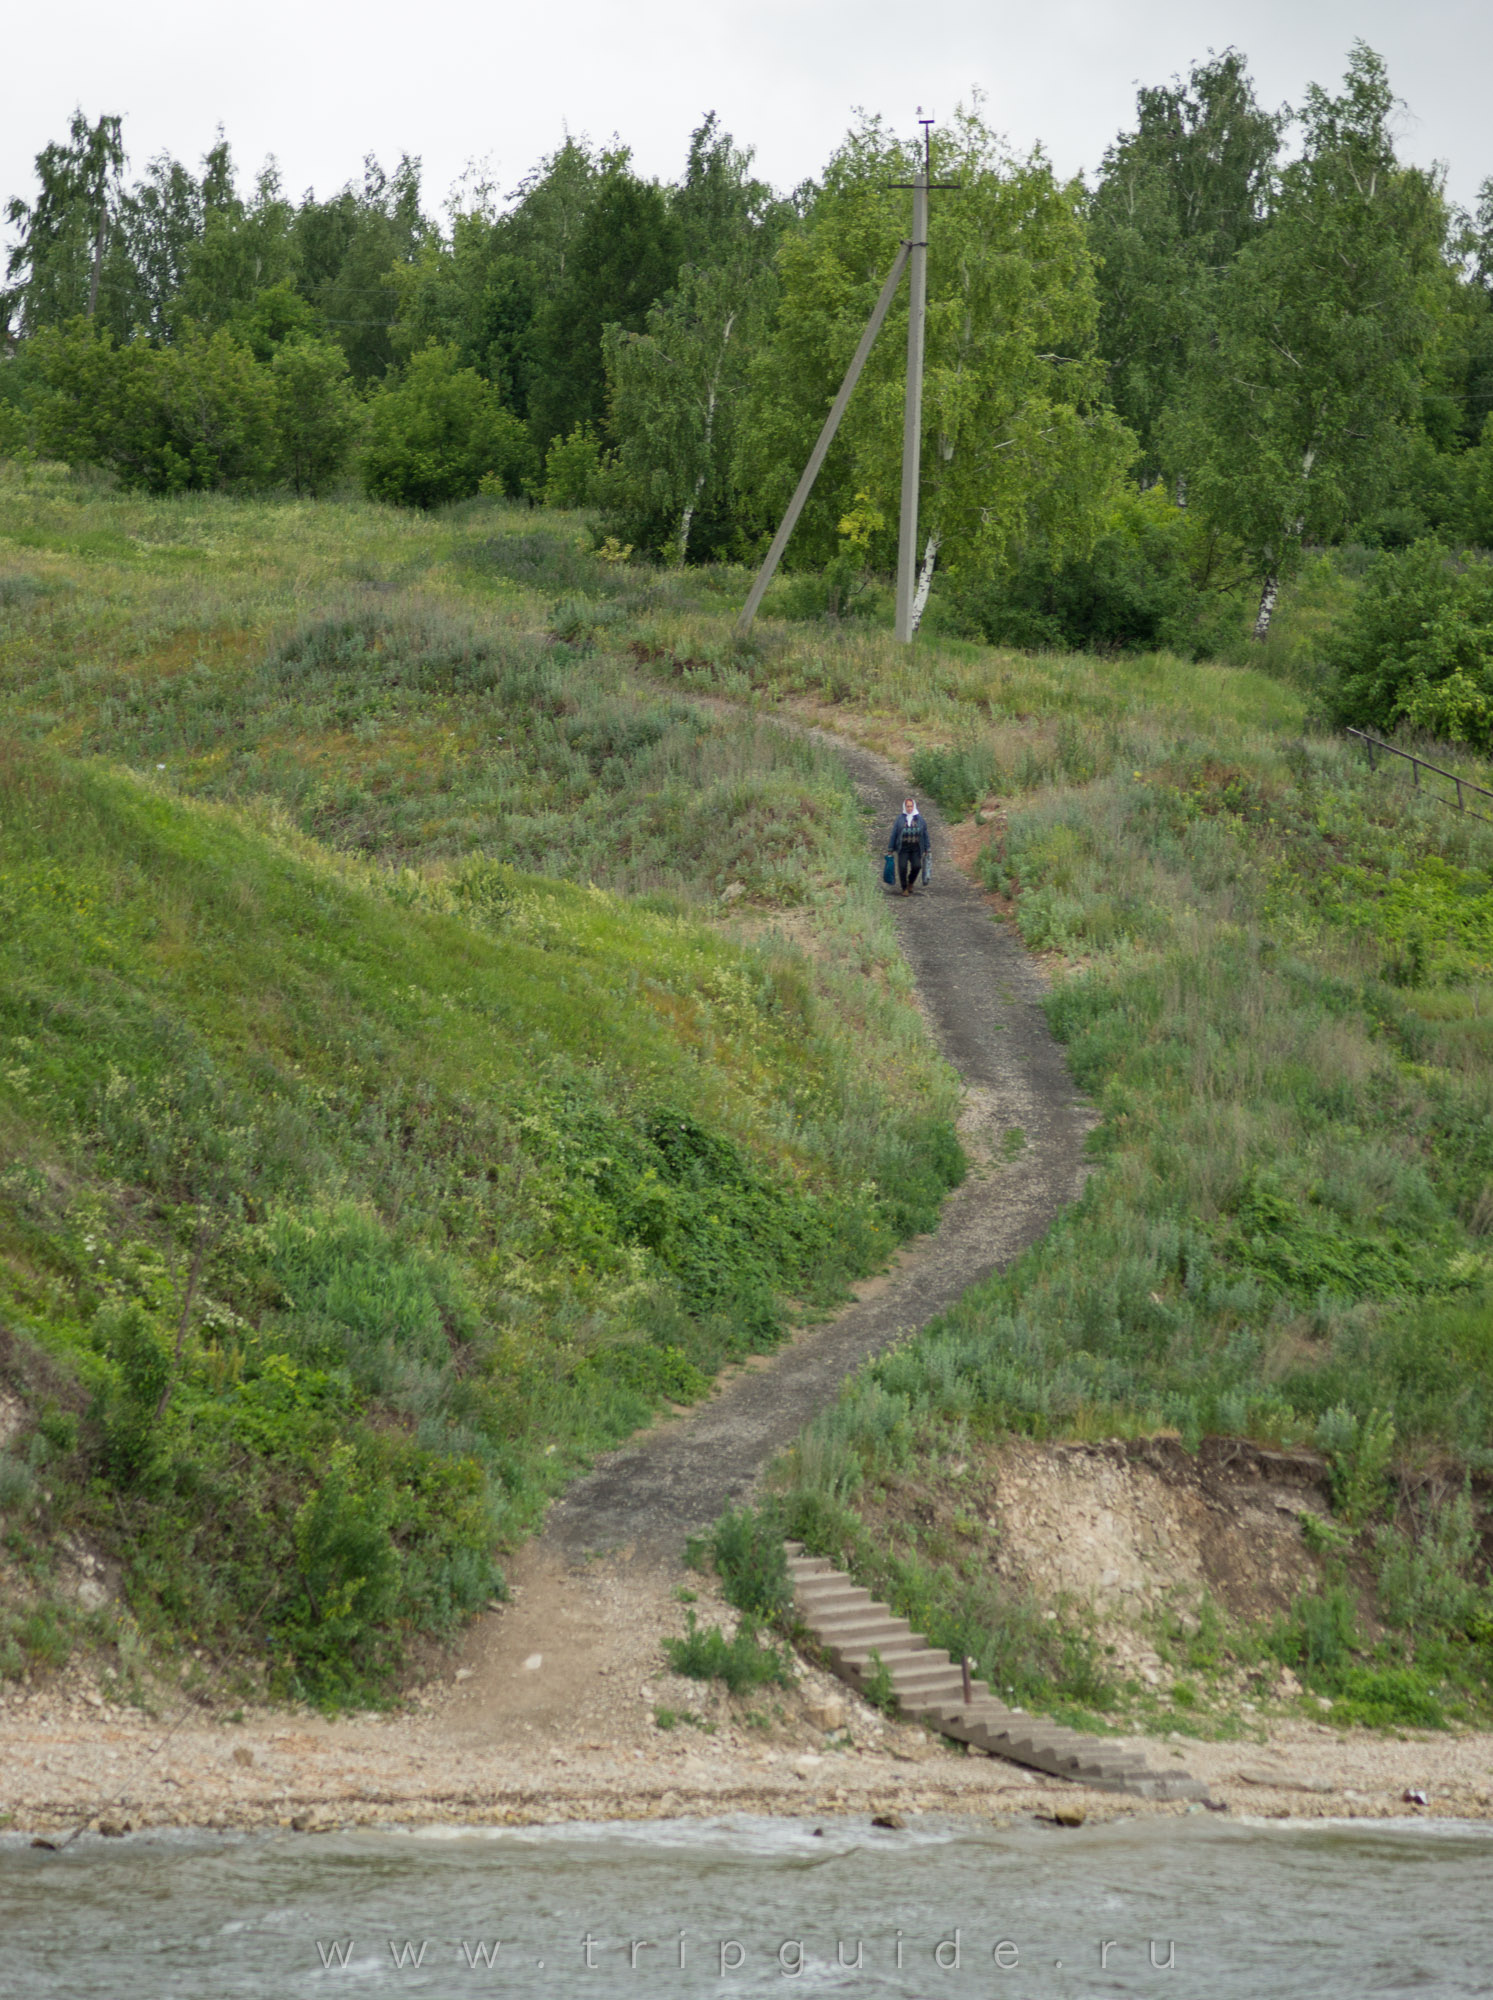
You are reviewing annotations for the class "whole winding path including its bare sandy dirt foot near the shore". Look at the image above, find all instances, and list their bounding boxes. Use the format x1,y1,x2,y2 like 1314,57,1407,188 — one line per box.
424,730,1093,1746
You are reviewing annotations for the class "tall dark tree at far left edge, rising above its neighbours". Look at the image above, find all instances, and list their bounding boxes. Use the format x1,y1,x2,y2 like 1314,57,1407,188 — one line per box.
4,110,124,334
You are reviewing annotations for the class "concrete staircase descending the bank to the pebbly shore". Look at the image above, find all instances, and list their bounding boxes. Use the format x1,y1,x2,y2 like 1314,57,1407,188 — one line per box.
787,1542,1209,1798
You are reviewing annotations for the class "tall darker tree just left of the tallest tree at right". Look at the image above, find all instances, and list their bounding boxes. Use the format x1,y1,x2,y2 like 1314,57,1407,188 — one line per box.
1089,48,1289,474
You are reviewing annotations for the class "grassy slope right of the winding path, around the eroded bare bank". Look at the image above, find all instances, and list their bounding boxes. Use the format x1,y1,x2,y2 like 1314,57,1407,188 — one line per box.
620,576,1493,1726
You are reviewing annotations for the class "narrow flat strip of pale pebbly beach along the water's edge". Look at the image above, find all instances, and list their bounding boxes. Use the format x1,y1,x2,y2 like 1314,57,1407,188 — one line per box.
0,1712,1493,1838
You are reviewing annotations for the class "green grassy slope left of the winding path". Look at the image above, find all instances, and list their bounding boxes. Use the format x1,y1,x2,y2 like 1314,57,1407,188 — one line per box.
0,476,957,1694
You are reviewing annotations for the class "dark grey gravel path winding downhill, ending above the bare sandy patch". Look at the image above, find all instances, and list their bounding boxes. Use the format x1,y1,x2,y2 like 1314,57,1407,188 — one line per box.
544,730,1093,1558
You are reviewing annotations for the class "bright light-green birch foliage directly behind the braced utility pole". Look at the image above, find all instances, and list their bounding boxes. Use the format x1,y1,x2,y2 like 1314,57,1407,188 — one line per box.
742,106,1135,604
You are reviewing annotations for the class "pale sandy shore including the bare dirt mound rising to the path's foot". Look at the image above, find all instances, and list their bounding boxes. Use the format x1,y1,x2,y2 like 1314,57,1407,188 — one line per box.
0,1546,1493,1838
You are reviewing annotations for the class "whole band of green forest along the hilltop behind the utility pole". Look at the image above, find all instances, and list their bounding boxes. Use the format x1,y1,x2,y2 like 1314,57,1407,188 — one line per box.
0,44,1493,744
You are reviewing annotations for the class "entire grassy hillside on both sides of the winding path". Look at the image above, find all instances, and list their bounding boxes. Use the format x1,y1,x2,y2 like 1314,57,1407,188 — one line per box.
0,458,1493,1726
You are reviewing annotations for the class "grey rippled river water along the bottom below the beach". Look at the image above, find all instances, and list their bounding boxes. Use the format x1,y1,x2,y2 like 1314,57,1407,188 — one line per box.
0,1814,1493,2000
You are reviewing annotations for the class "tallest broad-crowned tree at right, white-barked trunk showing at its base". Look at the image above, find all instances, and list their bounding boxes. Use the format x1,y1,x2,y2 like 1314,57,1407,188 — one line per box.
1163,42,1445,638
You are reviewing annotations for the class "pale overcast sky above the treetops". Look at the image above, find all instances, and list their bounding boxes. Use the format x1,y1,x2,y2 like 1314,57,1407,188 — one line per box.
0,0,1493,238
